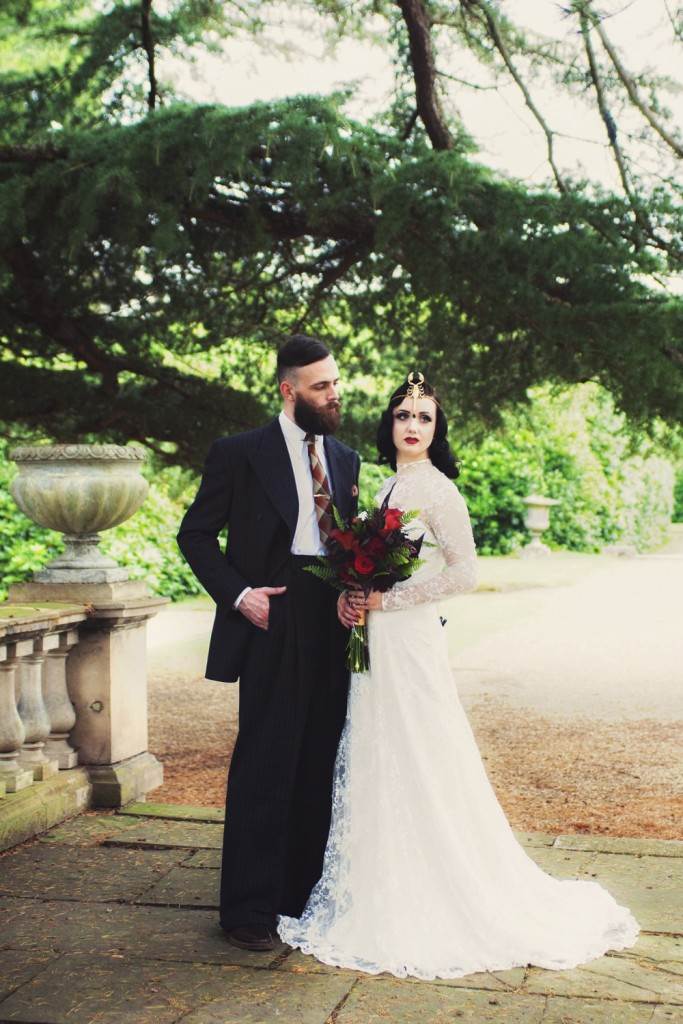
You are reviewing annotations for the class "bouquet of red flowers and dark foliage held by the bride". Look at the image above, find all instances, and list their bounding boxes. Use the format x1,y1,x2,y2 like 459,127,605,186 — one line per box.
308,487,424,672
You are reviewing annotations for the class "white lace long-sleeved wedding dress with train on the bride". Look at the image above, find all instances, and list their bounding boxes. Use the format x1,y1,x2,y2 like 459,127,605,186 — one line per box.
279,460,639,979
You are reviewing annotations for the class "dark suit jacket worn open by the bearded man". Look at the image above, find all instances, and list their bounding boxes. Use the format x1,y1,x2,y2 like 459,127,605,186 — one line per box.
177,419,360,682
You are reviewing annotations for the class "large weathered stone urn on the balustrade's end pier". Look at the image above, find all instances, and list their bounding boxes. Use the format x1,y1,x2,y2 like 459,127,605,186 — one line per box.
10,444,148,583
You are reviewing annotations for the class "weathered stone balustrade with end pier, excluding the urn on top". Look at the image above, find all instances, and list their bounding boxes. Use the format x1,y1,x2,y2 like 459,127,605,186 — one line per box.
0,595,164,850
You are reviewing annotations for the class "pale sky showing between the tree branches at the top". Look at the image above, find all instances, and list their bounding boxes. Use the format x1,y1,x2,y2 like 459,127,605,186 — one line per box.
165,0,683,194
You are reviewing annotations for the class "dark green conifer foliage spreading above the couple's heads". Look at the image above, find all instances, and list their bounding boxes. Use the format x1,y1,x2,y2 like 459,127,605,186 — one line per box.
0,0,683,468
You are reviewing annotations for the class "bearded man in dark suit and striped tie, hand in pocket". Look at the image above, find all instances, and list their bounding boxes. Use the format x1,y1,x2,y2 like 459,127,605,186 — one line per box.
178,335,360,950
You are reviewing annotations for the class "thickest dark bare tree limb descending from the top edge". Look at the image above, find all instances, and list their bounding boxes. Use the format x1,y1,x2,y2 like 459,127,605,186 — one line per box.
396,0,455,150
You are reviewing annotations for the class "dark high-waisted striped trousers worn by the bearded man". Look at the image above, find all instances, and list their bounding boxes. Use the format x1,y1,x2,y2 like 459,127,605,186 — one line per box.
220,555,349,929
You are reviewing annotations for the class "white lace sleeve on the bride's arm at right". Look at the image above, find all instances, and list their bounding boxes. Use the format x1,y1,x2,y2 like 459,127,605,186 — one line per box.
382,480,476,611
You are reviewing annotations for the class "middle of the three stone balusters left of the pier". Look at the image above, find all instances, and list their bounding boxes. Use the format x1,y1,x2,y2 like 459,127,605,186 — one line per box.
17,633,59,781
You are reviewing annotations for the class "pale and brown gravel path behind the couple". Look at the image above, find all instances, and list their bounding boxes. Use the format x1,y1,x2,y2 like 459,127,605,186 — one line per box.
150,531,683,839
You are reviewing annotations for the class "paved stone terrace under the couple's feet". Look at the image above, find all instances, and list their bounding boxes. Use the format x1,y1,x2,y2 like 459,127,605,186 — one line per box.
0,804,683,1024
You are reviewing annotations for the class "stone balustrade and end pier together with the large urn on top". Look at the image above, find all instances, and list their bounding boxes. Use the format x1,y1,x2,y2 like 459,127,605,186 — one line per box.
0,444,167,850
